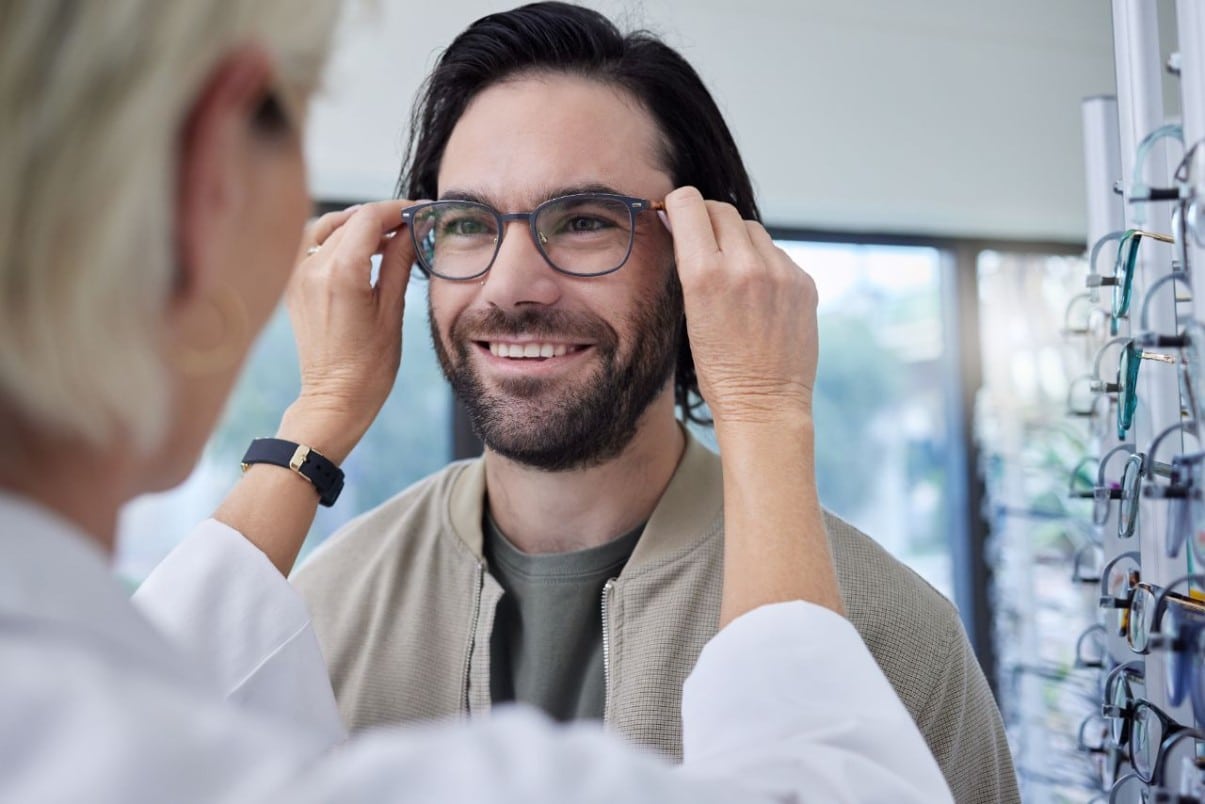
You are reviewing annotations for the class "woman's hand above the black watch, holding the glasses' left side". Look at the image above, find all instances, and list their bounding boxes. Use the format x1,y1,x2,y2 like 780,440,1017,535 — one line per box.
278,201,415,464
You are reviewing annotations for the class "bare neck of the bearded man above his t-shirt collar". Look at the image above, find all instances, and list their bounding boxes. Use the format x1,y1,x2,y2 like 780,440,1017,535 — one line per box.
486,394,686,553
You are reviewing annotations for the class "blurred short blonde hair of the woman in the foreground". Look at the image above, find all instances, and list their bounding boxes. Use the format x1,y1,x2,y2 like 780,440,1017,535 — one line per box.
0,0,339,448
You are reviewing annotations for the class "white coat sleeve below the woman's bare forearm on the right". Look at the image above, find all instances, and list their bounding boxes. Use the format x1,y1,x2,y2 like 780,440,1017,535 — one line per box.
682,601,952,802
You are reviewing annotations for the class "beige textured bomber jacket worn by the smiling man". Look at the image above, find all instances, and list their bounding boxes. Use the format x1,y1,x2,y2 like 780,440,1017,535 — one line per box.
293,436,1019,804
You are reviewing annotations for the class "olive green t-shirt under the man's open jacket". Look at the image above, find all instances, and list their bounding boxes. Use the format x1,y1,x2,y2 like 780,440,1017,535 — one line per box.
483,515,643,721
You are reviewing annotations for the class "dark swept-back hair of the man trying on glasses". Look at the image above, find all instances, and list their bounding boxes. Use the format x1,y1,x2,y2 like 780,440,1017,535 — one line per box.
398,2,760,424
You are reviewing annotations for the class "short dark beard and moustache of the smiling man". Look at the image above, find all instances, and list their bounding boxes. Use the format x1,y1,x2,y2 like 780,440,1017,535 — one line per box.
428,268,683,471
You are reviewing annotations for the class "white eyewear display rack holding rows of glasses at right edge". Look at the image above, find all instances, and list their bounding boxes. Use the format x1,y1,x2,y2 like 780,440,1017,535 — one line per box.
1023,0,1205,804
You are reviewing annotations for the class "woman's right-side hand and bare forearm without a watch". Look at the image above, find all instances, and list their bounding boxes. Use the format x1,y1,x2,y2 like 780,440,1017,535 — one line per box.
665,187,844,626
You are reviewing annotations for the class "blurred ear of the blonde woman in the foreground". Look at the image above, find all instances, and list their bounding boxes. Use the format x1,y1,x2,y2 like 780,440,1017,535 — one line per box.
174,46,275,303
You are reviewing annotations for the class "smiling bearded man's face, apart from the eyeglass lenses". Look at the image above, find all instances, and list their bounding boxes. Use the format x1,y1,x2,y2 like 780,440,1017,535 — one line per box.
430,76,682,471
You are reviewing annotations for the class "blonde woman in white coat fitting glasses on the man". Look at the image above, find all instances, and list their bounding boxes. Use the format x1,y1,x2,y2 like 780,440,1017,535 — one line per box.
0,0,948,802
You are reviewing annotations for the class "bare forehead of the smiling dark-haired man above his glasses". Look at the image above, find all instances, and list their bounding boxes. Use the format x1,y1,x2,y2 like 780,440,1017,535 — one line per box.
439,75,672,210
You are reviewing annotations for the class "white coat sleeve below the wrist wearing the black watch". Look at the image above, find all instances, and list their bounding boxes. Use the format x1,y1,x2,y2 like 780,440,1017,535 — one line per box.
134,520,346,744
